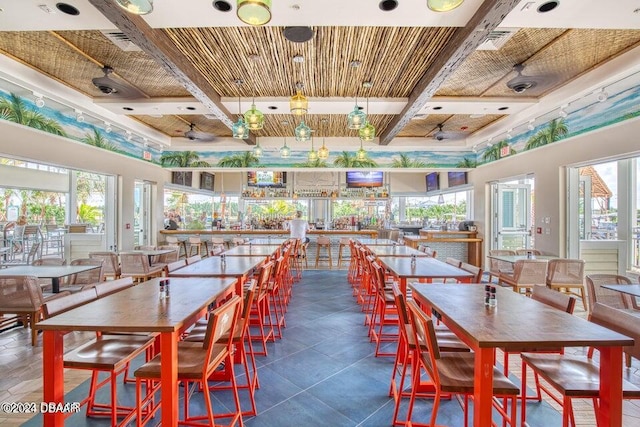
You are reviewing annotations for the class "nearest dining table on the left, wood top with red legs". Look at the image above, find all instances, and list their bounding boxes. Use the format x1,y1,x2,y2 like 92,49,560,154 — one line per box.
36,278,236,427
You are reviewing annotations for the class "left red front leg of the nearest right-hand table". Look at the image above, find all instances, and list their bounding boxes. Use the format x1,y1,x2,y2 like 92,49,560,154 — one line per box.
473,348,495,427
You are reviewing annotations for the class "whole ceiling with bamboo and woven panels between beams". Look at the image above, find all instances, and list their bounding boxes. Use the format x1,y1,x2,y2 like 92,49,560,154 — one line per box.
0,0,640,150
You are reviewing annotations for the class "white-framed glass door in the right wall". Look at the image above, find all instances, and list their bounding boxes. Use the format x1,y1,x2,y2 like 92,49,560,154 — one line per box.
491,184,531,250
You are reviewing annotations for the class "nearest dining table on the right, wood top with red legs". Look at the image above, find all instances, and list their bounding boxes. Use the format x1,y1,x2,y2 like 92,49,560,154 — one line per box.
410,283,633,427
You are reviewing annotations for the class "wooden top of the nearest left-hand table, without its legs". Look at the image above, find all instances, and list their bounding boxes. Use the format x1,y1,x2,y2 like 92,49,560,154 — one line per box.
36,278,236,332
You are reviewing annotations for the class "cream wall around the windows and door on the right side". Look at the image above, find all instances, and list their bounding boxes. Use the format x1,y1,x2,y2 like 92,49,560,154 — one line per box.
469,115,640,256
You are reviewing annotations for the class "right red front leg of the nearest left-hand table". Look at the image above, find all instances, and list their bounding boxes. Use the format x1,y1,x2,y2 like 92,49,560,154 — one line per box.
160,332,179,426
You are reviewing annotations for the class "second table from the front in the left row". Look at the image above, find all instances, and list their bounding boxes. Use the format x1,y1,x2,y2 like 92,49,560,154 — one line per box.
169,256,267,295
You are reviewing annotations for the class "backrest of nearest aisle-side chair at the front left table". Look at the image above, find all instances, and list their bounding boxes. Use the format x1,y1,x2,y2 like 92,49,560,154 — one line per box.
202,295,241,370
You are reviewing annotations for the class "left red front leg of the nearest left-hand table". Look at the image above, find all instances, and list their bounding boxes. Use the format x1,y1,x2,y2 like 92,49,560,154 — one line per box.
42,331,64,427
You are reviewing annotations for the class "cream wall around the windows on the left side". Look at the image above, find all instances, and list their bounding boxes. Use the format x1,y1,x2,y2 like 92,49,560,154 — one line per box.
0,120,170,250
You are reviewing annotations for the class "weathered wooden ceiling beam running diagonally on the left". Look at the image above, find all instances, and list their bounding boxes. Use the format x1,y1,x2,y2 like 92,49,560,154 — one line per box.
89,0,256,145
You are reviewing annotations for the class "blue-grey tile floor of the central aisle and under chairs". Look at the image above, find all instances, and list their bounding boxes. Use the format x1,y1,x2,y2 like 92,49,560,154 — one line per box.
24,270,561,427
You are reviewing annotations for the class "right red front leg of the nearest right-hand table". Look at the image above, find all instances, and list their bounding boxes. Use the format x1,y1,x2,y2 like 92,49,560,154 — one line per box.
596,347,622,427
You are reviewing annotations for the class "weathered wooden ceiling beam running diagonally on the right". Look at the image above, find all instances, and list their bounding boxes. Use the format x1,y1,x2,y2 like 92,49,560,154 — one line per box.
378,0,520,145
